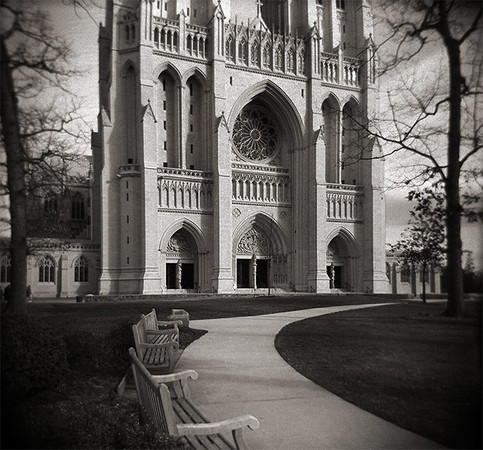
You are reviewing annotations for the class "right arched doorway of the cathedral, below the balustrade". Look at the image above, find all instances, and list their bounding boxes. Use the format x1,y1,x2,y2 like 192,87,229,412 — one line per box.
326,233,358,291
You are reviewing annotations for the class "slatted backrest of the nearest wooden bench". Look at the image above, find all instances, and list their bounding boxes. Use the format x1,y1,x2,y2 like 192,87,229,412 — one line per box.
129,348,179,436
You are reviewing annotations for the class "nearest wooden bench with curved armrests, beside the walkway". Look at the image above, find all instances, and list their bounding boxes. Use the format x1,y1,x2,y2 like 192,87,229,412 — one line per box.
129,348,259,449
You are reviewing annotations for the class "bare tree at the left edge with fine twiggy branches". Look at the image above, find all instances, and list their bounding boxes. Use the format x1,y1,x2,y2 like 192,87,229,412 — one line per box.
0,0,89,311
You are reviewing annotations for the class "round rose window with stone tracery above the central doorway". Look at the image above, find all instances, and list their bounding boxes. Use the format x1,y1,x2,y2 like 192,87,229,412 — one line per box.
232,109,277,161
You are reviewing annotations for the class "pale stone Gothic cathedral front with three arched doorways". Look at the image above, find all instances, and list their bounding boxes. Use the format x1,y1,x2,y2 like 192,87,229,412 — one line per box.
93,0,388,294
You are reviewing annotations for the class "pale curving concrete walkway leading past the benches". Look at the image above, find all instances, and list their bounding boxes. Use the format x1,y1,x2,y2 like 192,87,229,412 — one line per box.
176,304,444,450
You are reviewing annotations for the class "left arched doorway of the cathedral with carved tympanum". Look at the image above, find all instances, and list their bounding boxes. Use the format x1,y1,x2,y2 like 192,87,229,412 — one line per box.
165,228,199,290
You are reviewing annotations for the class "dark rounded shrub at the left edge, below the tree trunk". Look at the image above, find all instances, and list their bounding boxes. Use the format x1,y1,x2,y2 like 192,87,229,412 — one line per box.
1,313,68,404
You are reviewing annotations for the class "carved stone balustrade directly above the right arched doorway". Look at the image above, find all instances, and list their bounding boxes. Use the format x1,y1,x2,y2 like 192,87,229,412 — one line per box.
326,184,364,222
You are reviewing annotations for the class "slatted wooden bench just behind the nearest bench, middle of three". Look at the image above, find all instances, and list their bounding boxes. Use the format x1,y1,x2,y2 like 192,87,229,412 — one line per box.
132,317,179,373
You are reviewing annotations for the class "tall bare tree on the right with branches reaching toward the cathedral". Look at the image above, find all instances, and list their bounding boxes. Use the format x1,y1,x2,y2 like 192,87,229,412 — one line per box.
344,0,483,316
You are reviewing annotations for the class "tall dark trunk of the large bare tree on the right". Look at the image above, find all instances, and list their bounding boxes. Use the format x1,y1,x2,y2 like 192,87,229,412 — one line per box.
441,5,463,317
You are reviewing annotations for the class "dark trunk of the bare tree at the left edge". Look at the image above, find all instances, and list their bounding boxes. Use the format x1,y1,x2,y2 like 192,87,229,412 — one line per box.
0,39,27,311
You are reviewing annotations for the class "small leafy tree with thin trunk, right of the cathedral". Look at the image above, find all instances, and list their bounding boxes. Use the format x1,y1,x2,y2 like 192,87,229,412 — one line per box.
392,188,445,303
